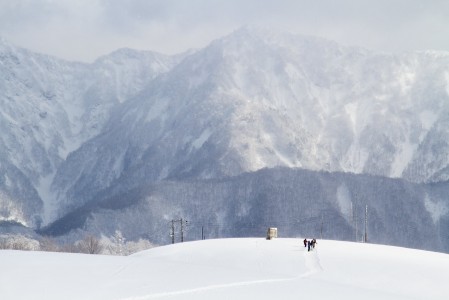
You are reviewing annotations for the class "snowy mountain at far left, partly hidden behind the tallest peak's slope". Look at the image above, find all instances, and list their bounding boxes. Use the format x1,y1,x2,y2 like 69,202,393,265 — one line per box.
0,40,181,226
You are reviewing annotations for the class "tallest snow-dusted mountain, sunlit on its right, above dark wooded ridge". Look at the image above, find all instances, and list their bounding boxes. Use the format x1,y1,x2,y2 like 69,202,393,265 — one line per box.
53,29,449,216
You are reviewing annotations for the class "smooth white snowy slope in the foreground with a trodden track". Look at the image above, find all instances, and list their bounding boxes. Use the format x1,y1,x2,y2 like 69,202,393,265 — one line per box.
0,238,449,300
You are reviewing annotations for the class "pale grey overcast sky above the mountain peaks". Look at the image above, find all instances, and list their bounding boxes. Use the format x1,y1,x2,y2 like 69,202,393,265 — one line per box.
0,0,449,62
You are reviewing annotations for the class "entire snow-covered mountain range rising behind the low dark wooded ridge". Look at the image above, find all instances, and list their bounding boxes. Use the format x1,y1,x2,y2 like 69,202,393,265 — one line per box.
0,28,449,251
